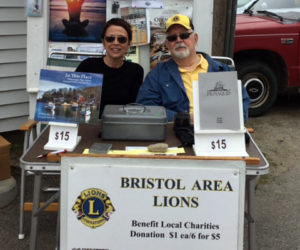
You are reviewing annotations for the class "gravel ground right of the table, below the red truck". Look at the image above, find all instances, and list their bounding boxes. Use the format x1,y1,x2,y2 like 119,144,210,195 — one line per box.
249,95,300,250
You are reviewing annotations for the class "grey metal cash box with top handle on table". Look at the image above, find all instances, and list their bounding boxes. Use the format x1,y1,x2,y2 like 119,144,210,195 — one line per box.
102,104,167,141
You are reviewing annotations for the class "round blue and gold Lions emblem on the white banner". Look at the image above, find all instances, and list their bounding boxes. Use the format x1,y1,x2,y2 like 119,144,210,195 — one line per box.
72,188,115,228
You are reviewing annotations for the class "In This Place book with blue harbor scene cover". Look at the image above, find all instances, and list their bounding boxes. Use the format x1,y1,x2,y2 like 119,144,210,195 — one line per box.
34,69,103,124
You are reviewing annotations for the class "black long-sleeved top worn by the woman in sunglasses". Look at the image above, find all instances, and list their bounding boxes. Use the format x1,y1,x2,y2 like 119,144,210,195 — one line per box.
76,58,144,118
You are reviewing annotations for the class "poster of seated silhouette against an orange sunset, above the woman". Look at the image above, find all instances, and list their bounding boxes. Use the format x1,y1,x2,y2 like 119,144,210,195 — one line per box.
49,0,106,43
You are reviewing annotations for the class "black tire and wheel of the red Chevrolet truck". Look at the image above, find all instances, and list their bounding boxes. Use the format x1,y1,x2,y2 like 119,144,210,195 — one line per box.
236,61,278,117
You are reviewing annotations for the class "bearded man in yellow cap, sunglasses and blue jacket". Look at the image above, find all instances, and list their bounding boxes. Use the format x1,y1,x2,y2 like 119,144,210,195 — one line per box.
136,14,250,122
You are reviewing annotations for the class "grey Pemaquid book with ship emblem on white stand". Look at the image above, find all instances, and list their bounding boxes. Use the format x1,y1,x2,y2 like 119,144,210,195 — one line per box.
194,71,242,130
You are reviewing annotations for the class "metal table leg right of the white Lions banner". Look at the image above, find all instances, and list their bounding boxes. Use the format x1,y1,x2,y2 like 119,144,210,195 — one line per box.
247,175,257,250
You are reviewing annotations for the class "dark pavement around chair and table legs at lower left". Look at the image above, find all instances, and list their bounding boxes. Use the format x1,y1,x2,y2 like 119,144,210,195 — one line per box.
0,131,59,250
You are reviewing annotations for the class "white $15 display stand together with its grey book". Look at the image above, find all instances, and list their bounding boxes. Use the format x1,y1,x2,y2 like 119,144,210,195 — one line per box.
193,71,248,156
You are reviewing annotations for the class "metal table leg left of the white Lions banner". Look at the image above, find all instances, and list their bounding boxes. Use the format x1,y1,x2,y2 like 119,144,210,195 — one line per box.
29,173,42,250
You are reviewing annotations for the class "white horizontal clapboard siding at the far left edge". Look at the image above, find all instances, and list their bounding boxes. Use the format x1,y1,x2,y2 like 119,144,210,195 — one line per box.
0,0,29,132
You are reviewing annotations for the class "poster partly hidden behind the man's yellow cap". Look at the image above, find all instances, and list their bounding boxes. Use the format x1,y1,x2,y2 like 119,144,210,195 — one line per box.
149,0,193,69
